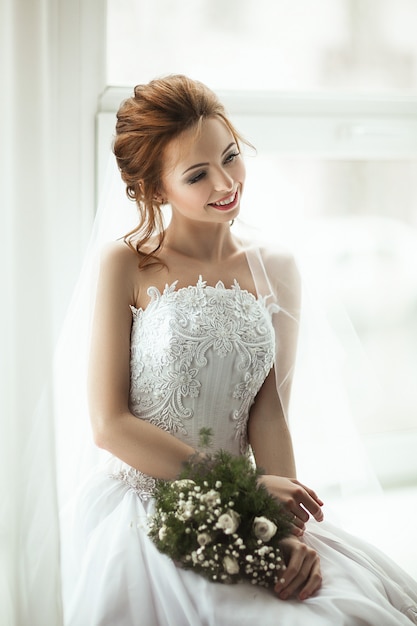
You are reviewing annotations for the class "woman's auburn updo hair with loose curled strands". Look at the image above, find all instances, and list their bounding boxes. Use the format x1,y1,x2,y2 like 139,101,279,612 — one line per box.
113,75,243,268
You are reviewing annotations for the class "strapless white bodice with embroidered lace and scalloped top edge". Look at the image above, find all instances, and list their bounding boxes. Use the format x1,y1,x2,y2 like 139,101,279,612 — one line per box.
109,278,274,495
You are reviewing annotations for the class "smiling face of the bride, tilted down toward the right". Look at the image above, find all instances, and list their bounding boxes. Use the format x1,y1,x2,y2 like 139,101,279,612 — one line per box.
162,117,245,223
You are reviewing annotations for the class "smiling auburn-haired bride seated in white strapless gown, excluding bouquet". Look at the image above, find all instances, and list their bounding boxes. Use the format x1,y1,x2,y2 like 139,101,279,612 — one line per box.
64,76,417,626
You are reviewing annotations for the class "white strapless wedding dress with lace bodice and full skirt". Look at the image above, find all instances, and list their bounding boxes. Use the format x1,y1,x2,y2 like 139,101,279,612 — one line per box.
63,280,417,626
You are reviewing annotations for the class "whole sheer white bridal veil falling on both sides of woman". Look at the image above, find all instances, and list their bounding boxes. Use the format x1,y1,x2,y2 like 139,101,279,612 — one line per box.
54,155,379,520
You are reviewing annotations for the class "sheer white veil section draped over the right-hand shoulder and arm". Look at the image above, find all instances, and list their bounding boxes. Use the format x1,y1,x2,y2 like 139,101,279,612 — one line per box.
236,222,381,499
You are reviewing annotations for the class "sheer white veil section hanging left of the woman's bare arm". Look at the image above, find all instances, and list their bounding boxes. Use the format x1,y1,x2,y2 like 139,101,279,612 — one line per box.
54,155,136,506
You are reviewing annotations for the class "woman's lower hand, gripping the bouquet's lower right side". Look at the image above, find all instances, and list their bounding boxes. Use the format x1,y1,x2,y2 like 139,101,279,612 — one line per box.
274,537,322,600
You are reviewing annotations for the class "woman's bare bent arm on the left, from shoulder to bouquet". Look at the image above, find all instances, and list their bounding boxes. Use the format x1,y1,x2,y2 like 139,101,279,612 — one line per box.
88,244,194,479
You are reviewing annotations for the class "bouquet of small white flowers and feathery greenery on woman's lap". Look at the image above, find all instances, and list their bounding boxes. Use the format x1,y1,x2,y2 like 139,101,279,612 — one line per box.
148,428,291,587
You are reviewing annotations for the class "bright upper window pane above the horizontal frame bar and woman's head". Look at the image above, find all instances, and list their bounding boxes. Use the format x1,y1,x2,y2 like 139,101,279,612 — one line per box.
107,0,417,92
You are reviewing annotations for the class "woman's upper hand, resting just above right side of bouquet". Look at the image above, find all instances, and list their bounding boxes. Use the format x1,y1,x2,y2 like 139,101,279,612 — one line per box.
259,474,323,535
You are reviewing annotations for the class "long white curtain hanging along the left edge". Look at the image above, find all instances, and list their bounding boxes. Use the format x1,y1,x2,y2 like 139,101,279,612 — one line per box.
0,0,105,626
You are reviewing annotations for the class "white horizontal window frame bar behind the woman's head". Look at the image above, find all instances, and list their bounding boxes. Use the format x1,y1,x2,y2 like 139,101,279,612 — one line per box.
96,87,417,189
